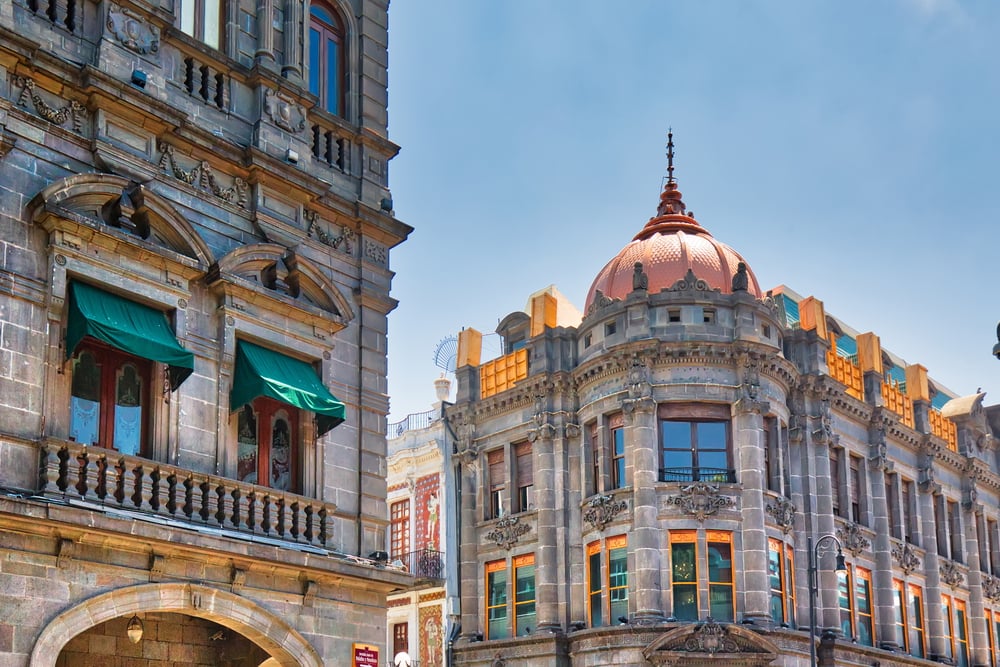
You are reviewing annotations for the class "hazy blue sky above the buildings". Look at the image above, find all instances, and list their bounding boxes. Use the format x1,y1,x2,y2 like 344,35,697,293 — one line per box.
378,0,1000,422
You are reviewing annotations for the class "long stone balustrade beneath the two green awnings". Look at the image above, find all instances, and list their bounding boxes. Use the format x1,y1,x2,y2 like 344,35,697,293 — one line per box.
39,441,336,547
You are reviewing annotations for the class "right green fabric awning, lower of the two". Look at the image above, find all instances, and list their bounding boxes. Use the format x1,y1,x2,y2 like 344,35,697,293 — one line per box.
229,340,344,435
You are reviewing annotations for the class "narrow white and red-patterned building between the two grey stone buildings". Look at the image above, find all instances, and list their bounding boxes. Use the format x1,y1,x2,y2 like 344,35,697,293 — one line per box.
386,376,458,667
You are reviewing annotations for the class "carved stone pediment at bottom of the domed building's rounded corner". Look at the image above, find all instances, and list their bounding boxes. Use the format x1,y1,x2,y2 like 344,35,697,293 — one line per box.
642,618,778,667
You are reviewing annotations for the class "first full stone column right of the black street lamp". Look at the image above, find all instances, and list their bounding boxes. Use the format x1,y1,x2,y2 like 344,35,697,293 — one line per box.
868,422,900,651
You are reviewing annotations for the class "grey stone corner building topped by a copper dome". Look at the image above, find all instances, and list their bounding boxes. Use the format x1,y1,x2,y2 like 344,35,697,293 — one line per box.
447,151,1000,667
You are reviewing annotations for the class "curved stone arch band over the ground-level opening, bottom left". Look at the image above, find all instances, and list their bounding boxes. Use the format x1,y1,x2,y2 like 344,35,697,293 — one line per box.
28,583,323,667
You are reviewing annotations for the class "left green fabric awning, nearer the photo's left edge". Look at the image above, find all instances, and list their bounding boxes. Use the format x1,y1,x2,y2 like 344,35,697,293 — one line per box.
66,282,194,390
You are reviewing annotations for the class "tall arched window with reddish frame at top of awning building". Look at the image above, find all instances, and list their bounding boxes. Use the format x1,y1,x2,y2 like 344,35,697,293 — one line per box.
309,4,344,116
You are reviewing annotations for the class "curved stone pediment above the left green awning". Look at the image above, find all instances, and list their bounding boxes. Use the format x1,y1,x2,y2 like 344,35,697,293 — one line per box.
28,173,214,267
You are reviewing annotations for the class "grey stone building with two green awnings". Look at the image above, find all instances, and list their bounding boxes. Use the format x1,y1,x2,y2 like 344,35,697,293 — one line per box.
0,0,412,666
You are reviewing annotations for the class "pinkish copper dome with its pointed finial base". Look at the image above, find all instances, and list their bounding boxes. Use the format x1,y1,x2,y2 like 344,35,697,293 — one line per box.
584,170,761,312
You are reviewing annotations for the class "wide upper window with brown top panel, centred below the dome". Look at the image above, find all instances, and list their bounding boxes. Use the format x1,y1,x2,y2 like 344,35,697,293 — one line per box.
660,404,736,483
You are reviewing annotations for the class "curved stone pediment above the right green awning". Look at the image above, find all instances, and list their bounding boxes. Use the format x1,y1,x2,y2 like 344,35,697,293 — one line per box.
208,243,354,323
